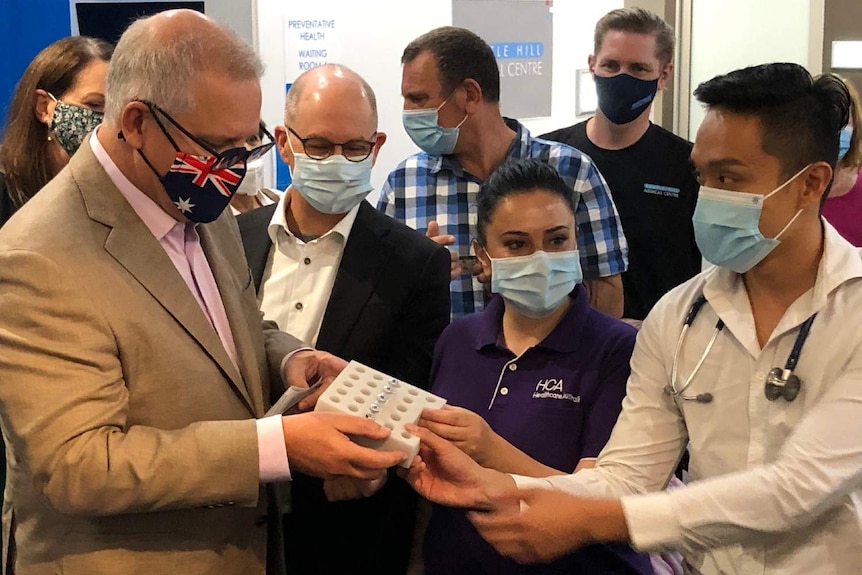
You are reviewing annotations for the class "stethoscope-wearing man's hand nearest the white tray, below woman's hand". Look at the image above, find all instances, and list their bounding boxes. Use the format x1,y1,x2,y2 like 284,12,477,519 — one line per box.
404,425,515,509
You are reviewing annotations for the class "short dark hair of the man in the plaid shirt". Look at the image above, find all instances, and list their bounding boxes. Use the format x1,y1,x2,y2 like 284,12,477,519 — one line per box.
401,26,500,103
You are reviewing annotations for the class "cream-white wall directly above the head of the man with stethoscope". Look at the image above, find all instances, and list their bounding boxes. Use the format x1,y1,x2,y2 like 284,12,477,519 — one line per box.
688,0,823,140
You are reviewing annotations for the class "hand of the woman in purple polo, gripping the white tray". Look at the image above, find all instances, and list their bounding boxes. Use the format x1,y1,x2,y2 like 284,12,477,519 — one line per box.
419,405,497,465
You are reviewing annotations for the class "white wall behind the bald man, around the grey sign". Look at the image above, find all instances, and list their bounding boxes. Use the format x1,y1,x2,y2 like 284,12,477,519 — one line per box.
257,0,623,191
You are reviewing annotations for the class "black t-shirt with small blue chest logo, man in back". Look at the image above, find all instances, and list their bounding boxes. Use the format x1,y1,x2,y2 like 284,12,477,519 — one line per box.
541,121,701,319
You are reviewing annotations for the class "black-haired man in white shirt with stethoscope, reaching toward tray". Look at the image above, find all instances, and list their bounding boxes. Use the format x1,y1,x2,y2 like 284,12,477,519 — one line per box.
409,64,862,575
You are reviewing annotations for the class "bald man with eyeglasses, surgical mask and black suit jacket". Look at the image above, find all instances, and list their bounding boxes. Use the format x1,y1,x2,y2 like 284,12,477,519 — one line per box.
239,64,449,575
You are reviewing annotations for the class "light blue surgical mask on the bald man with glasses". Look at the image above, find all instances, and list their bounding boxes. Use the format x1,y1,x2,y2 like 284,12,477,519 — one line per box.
287,138,373,214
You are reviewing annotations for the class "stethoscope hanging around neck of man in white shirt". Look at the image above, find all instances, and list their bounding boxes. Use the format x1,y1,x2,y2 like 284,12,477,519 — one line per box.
664,294,817,403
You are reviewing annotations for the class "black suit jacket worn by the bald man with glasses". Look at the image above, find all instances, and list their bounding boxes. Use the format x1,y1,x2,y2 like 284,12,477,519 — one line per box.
238,202,450,575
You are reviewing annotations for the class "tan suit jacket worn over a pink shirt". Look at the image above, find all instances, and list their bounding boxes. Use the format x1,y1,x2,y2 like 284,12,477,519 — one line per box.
0,145,300,575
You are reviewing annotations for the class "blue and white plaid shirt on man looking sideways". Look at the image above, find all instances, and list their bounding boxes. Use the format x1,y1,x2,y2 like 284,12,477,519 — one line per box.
377,118,628,317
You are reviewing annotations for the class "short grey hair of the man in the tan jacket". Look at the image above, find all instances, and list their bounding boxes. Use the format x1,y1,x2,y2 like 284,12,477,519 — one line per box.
105,17,263,123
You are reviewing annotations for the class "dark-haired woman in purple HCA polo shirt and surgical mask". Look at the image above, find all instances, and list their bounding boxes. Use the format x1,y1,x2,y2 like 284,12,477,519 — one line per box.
420,160,653,575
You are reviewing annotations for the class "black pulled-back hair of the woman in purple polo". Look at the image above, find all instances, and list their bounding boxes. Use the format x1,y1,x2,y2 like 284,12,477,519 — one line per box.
476,159,577,246
